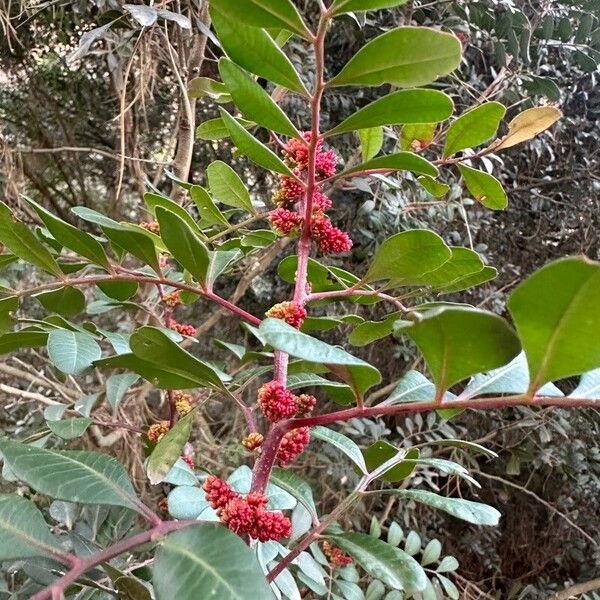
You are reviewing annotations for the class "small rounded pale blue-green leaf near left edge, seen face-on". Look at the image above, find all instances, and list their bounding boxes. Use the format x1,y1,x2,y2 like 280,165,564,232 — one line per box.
48,329,102,375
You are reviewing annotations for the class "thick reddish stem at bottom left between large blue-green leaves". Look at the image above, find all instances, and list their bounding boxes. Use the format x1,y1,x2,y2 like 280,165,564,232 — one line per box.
30,521,202,600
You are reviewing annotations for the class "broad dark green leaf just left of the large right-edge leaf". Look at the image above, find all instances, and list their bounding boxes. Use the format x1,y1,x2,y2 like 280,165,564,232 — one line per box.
401,307,520,397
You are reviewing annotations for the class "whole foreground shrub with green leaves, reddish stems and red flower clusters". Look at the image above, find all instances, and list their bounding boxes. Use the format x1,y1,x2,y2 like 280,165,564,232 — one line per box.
0,0,600,600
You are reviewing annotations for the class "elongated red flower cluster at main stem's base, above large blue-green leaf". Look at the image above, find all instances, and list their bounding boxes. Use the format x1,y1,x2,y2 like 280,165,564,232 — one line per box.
202,475,292,542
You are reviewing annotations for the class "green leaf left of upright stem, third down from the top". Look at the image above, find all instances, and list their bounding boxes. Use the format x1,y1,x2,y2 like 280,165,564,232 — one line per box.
219,58,300,137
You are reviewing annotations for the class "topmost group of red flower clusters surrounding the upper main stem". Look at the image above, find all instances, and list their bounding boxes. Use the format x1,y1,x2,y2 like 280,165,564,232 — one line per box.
269,132,352,253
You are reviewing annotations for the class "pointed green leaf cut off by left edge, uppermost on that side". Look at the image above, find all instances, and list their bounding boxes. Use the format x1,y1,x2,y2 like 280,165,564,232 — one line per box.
0,202,64,279
